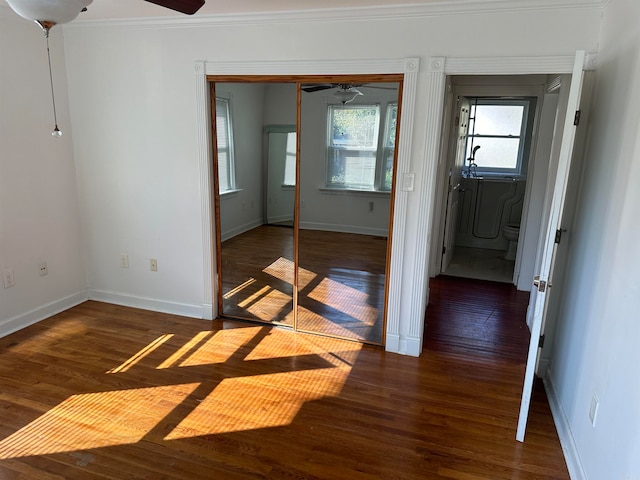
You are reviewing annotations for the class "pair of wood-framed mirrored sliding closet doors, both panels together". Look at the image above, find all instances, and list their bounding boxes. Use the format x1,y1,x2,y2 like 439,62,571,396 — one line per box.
209,75,402,345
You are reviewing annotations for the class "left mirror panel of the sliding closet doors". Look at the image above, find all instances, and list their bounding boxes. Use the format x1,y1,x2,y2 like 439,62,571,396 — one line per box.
215,82,297,325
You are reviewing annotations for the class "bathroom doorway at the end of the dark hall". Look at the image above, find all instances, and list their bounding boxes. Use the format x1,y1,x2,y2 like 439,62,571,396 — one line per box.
436,75,557,291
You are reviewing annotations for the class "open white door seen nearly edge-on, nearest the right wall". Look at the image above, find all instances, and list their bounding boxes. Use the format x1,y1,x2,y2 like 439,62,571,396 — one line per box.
516,51,585,442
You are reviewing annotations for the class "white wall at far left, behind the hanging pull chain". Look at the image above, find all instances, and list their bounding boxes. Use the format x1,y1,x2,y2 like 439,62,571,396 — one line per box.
0,5,86,336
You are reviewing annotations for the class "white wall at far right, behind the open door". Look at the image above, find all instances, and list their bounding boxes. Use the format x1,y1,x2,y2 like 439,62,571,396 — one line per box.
549,0,640,480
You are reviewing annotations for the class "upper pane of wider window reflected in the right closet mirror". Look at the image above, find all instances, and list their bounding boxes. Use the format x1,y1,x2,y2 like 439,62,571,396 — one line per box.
330,105,379,148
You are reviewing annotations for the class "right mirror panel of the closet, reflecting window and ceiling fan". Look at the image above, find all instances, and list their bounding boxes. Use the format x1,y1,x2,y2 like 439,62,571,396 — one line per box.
298,82,398,344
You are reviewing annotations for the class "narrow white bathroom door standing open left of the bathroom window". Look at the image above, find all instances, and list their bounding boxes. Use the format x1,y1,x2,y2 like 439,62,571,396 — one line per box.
440,97,470,272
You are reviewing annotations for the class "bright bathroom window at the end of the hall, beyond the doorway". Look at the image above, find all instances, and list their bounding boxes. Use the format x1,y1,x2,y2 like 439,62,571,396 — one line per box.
465,98,535,176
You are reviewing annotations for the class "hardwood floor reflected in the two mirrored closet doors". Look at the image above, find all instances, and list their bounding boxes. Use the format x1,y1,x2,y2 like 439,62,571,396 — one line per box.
222,225,387,345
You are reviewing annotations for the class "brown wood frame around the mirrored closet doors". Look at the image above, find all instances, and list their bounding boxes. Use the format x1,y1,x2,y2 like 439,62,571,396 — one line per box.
206,74,404,346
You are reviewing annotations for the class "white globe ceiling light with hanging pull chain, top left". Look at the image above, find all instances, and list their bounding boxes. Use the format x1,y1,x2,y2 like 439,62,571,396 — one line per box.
7,0,93,137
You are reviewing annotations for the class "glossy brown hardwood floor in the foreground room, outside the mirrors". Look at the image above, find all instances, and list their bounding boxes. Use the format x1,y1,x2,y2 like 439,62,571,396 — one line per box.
0,285,569,480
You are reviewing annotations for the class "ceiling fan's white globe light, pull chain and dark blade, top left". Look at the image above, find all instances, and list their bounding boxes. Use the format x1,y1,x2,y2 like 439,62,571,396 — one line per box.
6,0,205,137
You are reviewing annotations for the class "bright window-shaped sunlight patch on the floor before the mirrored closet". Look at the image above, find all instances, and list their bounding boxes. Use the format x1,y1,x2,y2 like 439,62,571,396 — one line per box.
0,327,362,459
